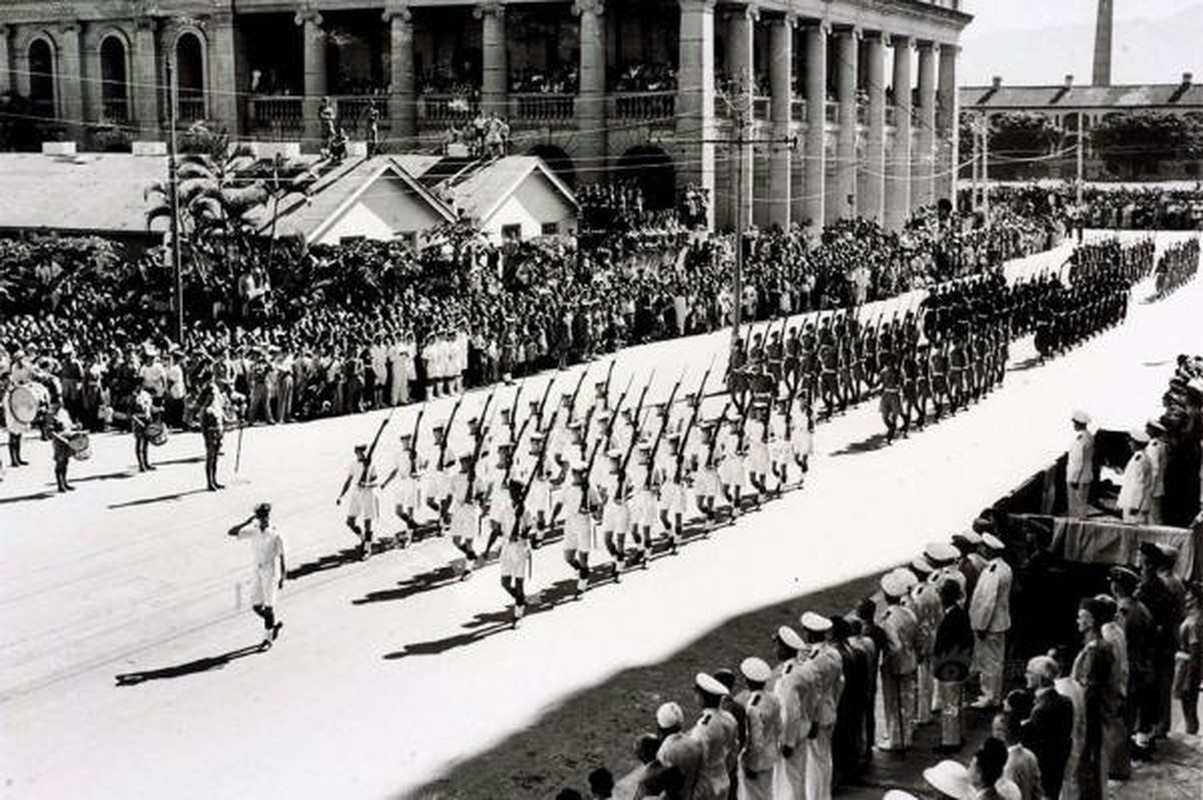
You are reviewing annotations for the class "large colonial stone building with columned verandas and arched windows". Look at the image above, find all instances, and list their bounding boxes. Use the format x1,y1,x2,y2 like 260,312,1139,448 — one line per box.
0,0,970,226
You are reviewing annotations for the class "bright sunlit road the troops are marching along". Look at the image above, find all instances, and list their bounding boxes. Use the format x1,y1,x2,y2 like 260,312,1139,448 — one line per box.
0,230,1203,800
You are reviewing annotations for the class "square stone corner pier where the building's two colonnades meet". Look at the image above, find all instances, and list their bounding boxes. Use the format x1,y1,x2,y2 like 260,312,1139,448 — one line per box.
676,0,716,229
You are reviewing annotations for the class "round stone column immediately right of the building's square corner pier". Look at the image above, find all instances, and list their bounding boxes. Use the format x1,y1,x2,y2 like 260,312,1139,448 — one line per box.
727,5,758,227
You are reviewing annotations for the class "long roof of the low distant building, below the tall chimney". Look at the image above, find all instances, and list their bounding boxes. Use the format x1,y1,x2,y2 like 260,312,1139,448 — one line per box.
960,83,1203,108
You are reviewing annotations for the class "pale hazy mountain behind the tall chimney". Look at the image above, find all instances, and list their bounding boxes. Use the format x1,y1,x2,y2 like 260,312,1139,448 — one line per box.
958,2,1203,85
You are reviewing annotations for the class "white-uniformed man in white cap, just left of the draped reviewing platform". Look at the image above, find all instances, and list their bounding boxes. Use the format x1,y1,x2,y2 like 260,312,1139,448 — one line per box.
968,533,1012,709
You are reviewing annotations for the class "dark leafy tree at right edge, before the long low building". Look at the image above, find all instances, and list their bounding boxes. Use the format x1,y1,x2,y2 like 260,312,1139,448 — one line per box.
1090,111,1203,178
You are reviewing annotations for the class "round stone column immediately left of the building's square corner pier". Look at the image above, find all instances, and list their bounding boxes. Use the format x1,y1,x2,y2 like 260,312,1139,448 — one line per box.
573,0,609,183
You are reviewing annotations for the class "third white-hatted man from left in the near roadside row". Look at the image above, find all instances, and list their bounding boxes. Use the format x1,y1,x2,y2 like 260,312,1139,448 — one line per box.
735,658,782,800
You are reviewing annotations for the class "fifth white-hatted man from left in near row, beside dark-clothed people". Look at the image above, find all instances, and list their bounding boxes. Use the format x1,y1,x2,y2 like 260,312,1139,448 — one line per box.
801,611,843,800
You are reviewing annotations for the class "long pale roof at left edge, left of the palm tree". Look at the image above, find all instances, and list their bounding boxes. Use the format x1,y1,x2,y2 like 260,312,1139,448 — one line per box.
0,153,167,233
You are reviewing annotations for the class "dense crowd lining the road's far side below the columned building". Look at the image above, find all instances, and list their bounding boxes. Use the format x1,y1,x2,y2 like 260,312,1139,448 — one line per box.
0,186,1154,442
